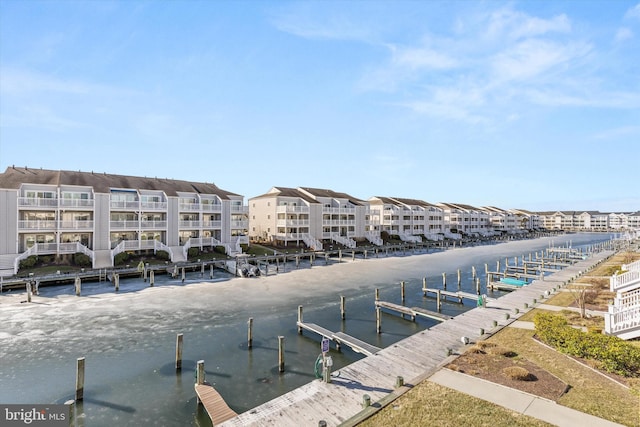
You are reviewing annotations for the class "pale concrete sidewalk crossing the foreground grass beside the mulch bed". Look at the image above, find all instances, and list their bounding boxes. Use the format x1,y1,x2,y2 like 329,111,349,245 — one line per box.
429,368,621,427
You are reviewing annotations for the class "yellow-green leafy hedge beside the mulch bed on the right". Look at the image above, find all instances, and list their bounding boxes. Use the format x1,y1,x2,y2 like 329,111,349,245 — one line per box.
533,313,640,377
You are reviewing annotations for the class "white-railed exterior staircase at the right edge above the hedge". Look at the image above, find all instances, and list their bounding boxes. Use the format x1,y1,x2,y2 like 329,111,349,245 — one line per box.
604,260,640,340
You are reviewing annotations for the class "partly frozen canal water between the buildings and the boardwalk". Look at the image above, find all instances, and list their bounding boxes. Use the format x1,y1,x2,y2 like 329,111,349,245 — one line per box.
0,233,611,426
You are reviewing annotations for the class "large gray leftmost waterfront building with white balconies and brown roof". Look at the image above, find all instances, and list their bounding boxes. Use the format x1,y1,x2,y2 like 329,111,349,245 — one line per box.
0,167,248,274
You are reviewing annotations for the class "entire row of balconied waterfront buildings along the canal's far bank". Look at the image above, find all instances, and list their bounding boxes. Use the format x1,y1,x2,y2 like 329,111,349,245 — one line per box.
0,167,640,275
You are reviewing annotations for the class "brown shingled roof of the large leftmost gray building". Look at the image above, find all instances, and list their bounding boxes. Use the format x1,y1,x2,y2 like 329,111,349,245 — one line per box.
0,167,240,199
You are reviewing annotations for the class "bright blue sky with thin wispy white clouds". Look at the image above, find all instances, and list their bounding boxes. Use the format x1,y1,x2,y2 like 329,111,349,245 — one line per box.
0,0,640,212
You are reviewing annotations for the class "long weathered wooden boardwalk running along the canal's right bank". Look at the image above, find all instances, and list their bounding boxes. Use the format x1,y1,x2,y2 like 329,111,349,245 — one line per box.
221,251,613,427
